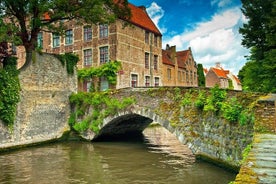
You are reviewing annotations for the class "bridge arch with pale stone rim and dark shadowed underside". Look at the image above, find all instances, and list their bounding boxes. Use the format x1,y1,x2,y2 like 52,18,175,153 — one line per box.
92,107,196,153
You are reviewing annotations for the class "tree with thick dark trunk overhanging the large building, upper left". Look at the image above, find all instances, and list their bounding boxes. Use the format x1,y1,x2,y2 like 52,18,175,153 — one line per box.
0,0,130,69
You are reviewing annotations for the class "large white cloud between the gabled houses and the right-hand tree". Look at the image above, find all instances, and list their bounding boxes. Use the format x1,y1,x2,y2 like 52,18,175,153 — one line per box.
163,7,248,74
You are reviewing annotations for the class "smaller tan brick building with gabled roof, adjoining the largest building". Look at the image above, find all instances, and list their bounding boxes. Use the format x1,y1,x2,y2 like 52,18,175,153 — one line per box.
162,45,198,86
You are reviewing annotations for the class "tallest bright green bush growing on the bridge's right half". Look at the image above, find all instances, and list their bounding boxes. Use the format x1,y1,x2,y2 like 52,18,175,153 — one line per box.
203,85,227,113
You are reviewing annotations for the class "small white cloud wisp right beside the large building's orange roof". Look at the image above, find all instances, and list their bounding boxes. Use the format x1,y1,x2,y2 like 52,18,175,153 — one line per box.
147,2,167,33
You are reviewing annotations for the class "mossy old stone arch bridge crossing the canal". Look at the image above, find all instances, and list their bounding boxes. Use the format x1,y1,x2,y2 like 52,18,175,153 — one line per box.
74,87,276,169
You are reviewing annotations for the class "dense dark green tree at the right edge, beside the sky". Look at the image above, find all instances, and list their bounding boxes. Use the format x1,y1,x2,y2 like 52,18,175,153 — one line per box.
239,0,276,92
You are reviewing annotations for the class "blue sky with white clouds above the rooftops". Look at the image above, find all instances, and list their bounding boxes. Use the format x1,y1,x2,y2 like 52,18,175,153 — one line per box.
129,0,249,75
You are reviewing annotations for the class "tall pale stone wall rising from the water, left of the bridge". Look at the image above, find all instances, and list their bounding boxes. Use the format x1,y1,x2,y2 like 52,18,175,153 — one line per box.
0,54,77,150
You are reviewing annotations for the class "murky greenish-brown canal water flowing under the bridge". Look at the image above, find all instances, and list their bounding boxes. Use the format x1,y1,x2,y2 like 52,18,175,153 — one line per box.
0,127,235,184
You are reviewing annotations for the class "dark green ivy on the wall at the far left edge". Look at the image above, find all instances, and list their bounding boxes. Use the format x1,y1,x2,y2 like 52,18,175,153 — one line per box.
0,57,20,126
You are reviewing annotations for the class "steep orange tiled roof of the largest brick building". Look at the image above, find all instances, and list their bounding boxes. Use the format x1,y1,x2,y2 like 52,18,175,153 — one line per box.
128,3,162,36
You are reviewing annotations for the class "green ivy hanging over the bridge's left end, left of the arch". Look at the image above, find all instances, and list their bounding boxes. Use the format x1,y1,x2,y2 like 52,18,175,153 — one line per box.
69,91,134,133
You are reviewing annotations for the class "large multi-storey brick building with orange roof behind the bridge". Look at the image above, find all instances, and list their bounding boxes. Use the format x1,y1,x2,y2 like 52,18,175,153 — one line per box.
17,4,162,91
